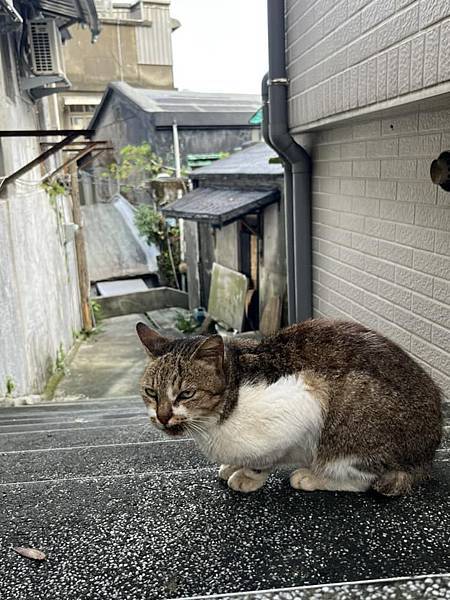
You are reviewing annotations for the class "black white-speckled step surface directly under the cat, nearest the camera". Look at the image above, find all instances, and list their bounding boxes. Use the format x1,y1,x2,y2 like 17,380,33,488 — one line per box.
0,463,450,600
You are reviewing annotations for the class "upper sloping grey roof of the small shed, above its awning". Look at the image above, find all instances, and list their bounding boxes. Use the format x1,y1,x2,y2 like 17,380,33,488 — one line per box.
191,142,283,179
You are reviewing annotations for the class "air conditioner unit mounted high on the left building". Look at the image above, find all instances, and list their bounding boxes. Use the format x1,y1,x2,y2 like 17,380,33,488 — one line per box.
28,19,66,79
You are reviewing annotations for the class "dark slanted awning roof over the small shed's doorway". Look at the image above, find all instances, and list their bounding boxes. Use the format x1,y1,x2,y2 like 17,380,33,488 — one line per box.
162,187,280,225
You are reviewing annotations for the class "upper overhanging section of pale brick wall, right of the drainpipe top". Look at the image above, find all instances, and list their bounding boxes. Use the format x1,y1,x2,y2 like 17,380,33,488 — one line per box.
286,0,450,132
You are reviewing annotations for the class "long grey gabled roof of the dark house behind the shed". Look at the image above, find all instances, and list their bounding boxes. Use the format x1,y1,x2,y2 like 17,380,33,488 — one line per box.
89,81,261,128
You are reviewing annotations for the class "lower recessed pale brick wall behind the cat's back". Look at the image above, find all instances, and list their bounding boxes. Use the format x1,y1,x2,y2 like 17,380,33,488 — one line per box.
312,106,450,398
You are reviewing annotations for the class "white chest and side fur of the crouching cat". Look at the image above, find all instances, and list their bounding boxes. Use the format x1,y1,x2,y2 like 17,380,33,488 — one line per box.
198,375,323,469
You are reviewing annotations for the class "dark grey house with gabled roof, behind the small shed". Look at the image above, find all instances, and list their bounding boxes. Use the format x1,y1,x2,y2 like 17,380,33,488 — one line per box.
83,82,261,202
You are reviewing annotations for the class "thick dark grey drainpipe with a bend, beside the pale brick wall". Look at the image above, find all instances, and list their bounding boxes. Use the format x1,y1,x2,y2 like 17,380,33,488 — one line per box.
263,0,312,323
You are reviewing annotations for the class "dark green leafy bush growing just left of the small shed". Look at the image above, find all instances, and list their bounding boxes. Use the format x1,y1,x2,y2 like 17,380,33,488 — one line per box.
134,204,181,287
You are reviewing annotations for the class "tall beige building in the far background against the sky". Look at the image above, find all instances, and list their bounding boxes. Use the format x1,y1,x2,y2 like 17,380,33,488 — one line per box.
60,0,180,128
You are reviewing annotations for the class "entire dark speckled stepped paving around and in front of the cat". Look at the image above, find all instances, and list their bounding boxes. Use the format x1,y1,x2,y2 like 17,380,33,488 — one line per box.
0,316,450,600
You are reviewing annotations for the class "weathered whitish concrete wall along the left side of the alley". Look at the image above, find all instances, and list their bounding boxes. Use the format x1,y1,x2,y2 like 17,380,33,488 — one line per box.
0,35,81,396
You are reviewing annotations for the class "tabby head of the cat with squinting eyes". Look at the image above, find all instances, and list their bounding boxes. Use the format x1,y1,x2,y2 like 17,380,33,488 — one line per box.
136,323,226,435
